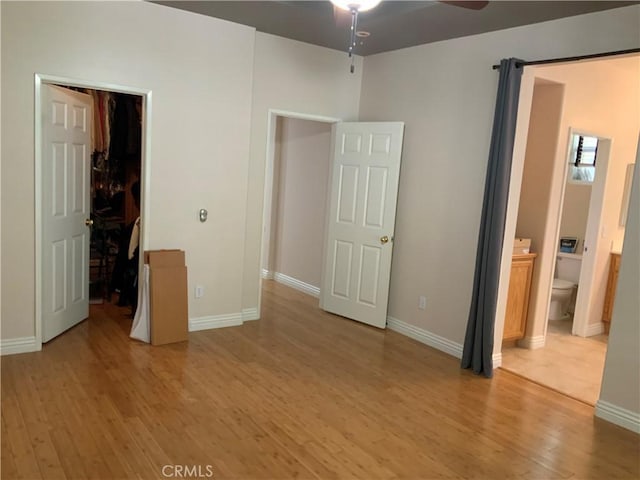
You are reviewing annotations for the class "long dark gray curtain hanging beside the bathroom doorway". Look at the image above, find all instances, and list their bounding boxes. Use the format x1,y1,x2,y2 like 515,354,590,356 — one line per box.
462,58,523,378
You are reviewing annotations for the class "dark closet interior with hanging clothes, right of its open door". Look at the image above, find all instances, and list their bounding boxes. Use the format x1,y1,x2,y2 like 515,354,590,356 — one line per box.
79,89,142,311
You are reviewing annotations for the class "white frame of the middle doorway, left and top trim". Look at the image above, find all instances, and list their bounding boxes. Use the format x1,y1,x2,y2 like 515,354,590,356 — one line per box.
258,108,343,315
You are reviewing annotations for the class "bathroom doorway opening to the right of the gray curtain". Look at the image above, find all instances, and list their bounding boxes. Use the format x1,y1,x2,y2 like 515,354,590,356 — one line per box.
494,56,640,405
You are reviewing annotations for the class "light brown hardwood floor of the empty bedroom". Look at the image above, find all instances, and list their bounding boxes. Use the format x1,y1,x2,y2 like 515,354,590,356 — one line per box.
1,282,640,479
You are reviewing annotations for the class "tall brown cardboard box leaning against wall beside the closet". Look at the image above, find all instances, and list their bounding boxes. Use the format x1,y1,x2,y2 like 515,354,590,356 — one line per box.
144,250,189,345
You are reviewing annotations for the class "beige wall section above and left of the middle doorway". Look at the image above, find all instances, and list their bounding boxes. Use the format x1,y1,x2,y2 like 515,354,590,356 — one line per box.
243,32,363,310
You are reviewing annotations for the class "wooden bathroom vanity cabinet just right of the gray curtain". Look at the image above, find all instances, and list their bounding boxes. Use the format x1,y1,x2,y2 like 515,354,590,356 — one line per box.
502,253,537,342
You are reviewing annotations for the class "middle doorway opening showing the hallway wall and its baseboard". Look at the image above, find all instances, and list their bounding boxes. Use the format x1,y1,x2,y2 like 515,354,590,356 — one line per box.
260,111,339,308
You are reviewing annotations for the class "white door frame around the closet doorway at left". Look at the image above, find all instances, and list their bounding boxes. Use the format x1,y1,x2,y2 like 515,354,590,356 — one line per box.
34,73,152,350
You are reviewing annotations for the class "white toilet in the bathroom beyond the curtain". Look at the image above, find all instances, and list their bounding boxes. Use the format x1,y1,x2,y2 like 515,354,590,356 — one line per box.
549,252,582,320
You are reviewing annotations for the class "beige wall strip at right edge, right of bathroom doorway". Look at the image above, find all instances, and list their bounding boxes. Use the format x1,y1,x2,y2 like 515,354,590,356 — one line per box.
596,143,640,433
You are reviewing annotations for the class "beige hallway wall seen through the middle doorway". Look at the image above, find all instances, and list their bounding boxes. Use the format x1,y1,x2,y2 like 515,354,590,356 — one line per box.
273,118,331,288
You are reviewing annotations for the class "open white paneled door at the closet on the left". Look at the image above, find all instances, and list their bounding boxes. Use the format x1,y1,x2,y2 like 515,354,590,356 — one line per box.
41,84,93,342
